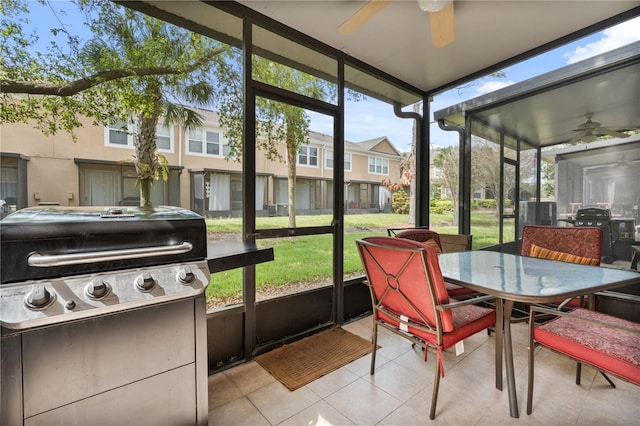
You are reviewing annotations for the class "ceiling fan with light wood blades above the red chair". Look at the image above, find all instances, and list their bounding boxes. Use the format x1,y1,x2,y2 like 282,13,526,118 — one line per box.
338,0,456,48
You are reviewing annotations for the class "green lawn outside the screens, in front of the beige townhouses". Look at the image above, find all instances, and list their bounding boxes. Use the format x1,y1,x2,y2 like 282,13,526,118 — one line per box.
207,213,508,301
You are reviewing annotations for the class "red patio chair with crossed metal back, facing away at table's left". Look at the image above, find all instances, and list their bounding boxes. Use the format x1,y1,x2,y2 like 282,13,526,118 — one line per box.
356,237,496,419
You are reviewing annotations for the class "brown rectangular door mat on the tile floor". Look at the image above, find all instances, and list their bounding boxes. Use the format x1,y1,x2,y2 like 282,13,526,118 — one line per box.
255,328,371,391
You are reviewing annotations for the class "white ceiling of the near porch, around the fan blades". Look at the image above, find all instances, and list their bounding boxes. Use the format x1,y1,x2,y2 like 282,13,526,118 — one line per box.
239,0,640,92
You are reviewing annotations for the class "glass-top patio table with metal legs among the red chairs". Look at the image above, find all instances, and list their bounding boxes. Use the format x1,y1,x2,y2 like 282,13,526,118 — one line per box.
438,251,640,417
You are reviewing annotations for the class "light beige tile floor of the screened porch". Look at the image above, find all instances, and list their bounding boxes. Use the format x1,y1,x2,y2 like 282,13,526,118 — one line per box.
209,317,640,426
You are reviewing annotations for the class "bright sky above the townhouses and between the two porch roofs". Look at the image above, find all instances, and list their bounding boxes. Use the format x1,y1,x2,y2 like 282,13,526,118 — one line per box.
322,18,640,151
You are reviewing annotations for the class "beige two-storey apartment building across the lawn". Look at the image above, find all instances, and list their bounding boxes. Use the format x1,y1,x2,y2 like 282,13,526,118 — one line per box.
0,110,402,217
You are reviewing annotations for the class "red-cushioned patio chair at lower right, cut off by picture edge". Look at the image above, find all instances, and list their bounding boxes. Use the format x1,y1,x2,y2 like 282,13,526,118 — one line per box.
527,306,640,414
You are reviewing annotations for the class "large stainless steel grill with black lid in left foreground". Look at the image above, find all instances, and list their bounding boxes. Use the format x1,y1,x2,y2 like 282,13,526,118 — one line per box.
0,207,209,425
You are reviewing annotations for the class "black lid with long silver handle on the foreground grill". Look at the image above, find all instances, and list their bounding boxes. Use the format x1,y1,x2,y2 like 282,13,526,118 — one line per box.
0,206,207,283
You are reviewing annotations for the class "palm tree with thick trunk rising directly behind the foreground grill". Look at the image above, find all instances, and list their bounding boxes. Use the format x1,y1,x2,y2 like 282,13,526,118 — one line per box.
84,2,226,208
